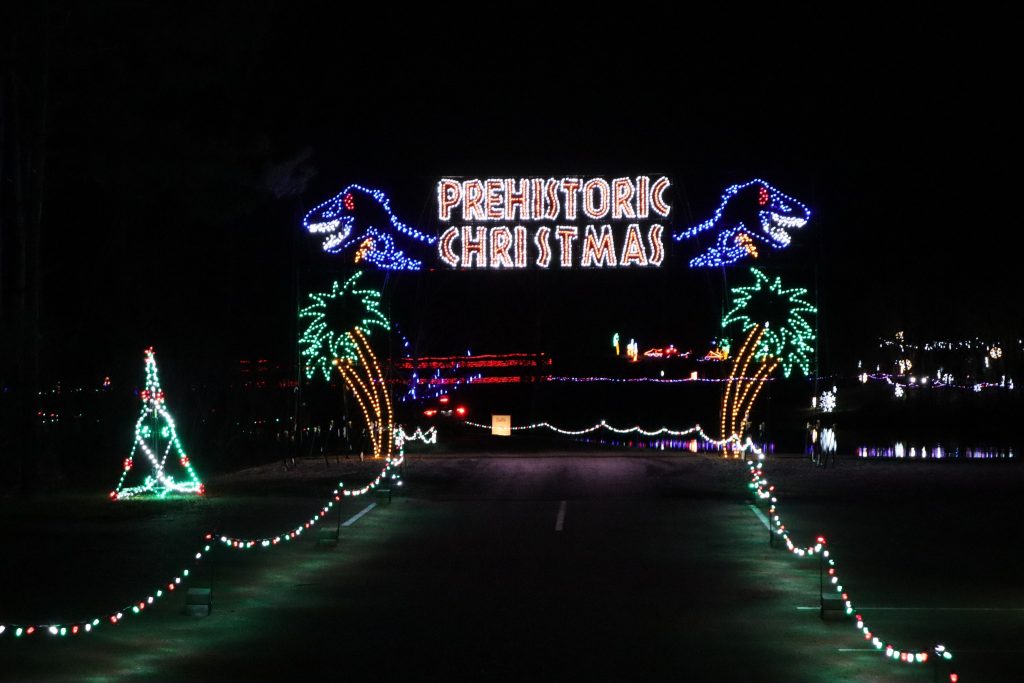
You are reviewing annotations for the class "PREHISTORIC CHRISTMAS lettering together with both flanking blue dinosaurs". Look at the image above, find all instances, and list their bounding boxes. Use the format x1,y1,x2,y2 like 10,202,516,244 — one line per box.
302,175,811,270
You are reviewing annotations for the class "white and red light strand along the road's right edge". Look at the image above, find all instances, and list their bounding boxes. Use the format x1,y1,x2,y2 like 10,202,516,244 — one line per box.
742,438,952,664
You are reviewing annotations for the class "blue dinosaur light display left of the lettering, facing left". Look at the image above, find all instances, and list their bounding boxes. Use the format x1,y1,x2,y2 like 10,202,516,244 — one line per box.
302,184,437,270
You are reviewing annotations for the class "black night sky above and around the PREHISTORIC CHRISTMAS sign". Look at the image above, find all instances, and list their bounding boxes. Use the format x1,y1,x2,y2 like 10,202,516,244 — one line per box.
0,1,1024,381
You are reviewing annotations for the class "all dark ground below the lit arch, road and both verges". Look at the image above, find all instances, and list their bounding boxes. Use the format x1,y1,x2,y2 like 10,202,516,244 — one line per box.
0,452,1024,682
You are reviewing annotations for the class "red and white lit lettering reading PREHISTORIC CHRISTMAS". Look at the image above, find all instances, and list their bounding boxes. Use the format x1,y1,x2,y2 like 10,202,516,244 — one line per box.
437,175,672,268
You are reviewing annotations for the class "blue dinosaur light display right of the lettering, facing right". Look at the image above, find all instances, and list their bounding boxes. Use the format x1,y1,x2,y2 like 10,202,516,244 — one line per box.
672,178,811,268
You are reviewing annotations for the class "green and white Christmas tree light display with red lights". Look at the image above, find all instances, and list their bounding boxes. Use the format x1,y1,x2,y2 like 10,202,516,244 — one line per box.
111,346,205,501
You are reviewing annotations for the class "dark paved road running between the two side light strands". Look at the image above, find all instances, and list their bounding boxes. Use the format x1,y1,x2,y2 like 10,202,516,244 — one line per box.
0,457,1007,681
